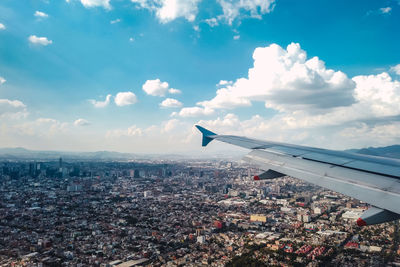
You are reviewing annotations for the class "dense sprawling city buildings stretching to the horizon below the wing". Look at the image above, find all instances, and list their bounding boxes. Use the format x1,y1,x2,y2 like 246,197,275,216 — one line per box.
0,158,400,267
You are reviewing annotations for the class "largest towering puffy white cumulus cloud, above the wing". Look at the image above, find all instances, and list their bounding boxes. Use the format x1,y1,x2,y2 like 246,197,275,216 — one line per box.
191,43,355,113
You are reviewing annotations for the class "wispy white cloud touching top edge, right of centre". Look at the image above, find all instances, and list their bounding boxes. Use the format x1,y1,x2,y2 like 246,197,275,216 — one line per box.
218,0,275,25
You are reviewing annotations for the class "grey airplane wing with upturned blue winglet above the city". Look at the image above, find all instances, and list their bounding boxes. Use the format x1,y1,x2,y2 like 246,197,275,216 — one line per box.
196,125,400,226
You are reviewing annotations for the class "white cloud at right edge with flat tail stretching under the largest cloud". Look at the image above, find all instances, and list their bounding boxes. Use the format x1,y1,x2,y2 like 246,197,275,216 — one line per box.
253,72,400,129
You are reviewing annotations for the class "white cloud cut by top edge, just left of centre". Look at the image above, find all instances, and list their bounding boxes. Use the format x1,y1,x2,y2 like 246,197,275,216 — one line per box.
131,0,201,23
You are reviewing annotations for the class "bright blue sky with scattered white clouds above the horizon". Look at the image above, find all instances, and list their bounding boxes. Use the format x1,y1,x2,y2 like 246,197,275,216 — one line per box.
0,0,400,154
